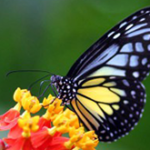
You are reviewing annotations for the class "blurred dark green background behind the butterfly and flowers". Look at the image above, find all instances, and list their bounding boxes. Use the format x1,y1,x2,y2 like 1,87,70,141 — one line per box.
0,0,150,150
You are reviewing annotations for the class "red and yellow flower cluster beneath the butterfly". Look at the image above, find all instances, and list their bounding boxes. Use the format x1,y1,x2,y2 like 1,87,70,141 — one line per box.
0,88,98,150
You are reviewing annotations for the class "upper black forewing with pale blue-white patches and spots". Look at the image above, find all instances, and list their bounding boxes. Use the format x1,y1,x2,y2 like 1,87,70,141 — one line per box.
67,8,150,81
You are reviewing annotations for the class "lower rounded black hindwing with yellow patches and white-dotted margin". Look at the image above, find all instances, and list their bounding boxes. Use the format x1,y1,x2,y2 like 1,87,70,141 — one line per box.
71,76,145,142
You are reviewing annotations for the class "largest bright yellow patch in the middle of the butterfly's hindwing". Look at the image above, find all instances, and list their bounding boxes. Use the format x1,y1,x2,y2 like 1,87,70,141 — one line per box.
77,87,120,103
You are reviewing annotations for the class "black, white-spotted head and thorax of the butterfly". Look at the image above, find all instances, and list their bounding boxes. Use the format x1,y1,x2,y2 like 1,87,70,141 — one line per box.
51,75,78,104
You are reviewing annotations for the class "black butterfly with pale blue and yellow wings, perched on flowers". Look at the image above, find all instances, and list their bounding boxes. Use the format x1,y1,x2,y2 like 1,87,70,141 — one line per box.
51,7,150,142
